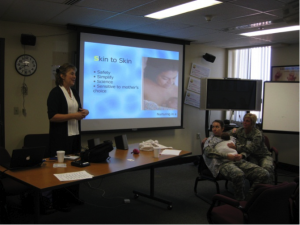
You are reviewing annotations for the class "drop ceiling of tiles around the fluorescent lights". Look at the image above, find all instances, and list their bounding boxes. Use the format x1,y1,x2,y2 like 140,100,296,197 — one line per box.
0,0,300,48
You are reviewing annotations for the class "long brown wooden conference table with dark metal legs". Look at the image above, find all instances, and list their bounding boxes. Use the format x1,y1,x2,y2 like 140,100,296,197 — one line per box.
0,143,191,224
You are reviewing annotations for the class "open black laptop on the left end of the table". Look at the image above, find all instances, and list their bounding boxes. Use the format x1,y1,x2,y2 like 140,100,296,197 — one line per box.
0,147,45,170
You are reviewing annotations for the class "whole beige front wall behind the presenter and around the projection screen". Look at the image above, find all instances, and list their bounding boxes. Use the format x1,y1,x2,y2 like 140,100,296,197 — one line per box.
0,21,226,157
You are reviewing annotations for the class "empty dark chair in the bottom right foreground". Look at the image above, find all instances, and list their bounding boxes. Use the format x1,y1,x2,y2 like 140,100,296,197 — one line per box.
207,182,296,225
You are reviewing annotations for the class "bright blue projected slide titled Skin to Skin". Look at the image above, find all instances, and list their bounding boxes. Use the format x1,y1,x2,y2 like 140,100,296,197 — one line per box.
82,42,179,119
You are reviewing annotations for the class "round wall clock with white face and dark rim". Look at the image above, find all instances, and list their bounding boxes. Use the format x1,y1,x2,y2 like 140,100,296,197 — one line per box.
15,55,37,76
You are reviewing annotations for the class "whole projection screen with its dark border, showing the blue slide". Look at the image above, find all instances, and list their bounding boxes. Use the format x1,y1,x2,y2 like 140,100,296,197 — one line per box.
75,29,184,132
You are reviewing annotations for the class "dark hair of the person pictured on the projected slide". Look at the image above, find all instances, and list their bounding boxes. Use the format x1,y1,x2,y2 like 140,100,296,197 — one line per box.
144,58,178,82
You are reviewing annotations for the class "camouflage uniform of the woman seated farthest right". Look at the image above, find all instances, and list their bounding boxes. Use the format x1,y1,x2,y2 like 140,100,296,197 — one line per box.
229,127,274,184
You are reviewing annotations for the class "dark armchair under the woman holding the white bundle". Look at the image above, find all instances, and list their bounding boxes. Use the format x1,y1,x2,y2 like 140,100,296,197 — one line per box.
194,142,228,204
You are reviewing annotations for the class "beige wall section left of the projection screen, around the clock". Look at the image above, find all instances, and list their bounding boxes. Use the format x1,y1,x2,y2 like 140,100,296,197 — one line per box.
0,22,76,151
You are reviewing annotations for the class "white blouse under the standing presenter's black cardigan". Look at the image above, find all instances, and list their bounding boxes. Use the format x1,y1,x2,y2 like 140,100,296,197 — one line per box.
59,86,79,136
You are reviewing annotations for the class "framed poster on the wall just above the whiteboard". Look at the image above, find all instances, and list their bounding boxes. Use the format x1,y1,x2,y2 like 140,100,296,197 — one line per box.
271,65,300,82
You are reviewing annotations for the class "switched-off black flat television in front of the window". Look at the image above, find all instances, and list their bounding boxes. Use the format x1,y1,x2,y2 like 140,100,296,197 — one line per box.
200,78,262,111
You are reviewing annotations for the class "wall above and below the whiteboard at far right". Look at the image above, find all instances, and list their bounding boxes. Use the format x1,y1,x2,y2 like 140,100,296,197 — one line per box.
266,44,300,166
